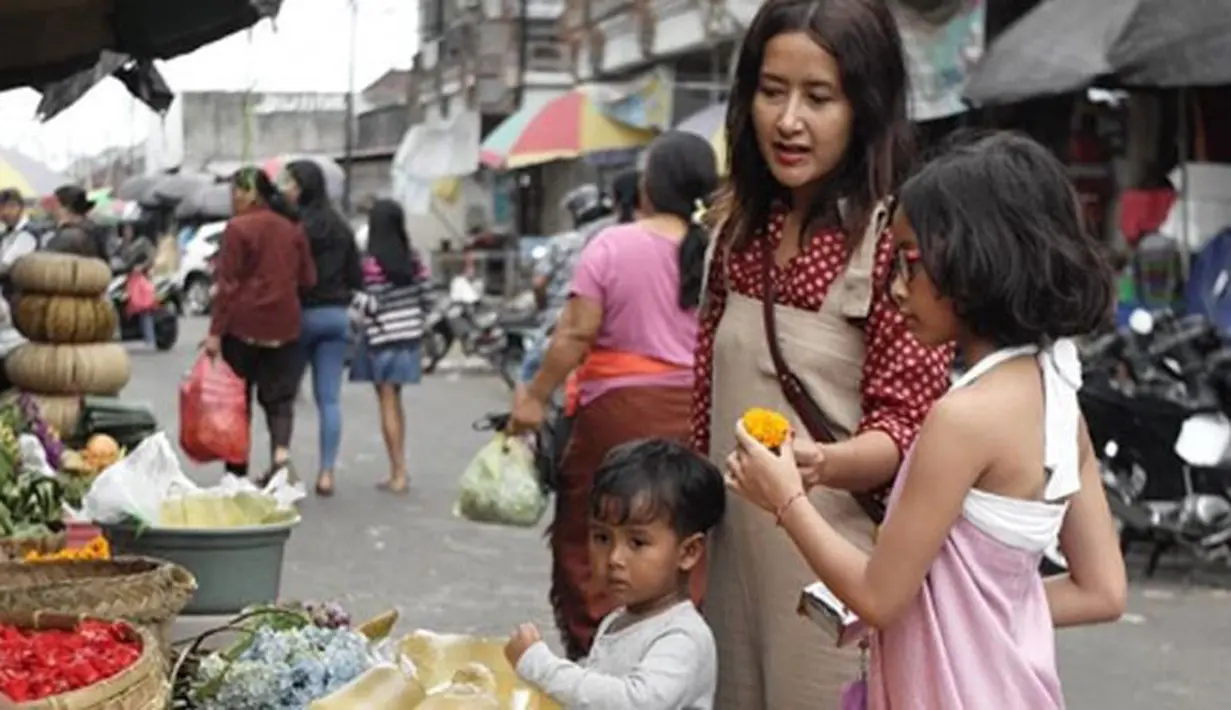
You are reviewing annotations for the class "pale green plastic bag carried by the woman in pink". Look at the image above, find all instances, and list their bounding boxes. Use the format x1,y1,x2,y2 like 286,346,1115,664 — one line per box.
454,433,548,528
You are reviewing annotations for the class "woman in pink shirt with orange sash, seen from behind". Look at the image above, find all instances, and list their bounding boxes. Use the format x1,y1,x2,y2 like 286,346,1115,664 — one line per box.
511,132,718,660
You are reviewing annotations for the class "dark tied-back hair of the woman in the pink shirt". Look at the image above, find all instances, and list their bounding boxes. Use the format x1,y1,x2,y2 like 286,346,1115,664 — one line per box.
643,130,718,310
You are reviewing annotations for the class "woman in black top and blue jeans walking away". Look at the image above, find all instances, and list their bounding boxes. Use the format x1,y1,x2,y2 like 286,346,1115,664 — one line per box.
283,160,363,496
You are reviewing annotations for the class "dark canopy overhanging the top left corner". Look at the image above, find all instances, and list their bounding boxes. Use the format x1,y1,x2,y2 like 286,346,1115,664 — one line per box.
0,0,282,90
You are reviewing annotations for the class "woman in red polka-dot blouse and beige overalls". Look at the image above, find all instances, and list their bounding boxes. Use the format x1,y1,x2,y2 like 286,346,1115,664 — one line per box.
693,0,953,710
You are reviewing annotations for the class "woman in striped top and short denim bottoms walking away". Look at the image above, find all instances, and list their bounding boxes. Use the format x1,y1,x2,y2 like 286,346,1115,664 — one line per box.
351,199,427,495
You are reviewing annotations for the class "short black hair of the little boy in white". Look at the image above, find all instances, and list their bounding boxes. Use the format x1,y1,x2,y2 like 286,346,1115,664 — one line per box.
590,439,726,538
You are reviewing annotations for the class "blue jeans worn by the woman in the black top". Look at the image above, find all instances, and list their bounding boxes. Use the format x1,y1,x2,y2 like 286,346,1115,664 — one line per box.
299,306,351,471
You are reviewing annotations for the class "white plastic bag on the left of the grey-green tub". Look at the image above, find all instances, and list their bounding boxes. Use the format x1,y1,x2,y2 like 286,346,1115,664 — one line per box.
82,432,201,525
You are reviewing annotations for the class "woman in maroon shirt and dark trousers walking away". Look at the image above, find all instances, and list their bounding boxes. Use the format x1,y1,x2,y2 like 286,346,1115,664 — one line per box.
203,167,316,485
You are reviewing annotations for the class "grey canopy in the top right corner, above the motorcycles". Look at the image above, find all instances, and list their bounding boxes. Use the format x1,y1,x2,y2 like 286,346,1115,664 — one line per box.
965,0,1231,103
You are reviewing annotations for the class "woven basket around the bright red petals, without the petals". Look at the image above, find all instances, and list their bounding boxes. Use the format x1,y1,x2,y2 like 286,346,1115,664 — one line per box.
0,612,171,710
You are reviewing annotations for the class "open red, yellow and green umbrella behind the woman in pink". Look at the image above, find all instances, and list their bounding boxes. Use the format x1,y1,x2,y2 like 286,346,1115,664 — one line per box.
480,90,655,169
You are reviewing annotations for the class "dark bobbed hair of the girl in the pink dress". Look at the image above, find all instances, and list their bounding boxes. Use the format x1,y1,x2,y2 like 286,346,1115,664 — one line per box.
899,132,1113,346
